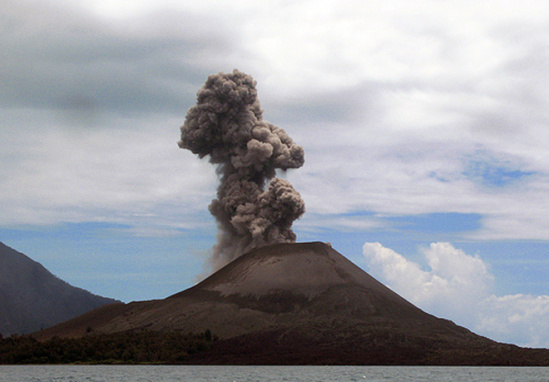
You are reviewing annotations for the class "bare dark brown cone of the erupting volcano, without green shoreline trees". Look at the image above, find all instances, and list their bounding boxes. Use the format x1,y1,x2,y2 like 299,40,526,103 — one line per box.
35,242,549,365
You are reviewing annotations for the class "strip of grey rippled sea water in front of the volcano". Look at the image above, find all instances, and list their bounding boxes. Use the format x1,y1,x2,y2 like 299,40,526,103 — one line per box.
0,365,549,382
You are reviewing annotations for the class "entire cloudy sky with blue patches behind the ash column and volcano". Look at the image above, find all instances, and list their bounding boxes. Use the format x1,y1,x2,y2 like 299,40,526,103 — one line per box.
0,0,549,347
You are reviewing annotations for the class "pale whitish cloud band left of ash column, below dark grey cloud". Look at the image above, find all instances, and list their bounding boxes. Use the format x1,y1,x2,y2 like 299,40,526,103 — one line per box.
0,112,216,228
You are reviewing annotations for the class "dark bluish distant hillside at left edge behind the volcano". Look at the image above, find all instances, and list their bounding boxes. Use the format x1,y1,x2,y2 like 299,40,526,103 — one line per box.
0,242,116,336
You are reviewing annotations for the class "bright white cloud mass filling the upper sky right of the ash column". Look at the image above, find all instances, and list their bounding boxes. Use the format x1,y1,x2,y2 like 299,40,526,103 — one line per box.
235,1,549,240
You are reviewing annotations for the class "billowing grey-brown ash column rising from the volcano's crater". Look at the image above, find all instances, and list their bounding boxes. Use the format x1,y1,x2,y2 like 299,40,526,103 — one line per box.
178,70,305,270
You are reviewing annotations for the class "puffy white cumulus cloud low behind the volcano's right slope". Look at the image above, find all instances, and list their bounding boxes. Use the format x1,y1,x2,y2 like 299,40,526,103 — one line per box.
363,243,549,347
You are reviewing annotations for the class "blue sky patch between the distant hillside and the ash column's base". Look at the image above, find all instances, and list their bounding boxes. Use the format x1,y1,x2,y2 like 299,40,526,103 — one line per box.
0,222,215,302
